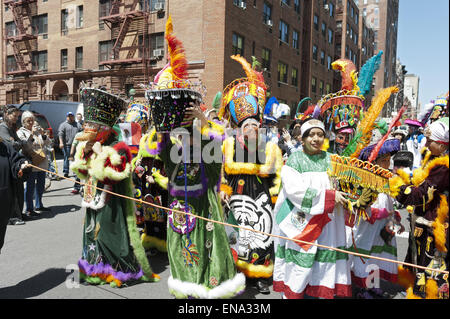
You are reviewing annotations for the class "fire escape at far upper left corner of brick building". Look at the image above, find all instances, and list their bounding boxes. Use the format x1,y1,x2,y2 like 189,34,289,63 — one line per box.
3,0,37,75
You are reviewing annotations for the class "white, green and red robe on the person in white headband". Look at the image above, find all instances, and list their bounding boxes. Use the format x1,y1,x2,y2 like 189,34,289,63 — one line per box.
273,151,352,298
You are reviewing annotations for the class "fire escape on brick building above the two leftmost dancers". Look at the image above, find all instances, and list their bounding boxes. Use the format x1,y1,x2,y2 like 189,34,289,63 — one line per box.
100,0,148,68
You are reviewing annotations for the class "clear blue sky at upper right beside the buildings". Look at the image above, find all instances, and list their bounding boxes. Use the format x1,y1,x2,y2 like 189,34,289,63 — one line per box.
397,0,450,106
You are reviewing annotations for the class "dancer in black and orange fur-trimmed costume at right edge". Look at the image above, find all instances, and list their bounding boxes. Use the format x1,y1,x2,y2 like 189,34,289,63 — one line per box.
390,117,449,299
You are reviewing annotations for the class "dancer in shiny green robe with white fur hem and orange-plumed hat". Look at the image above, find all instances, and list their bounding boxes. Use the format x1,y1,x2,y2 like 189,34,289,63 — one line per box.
146,17,245,299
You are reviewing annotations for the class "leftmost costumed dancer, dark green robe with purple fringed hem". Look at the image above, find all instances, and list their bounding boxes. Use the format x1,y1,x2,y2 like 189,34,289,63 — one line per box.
71,88,159,287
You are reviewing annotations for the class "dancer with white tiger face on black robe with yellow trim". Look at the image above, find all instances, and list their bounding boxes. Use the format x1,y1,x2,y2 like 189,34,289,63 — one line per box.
219,56,283,294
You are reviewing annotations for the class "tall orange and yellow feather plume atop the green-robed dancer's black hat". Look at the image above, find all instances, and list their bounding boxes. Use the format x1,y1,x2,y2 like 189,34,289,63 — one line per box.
154,16,188,89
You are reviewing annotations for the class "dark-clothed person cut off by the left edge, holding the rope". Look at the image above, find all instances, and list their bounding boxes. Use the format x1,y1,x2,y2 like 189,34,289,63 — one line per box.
0,138,29,254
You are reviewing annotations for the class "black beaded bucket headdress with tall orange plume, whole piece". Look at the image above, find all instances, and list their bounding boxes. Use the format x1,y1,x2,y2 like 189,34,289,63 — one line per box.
146,16,206,132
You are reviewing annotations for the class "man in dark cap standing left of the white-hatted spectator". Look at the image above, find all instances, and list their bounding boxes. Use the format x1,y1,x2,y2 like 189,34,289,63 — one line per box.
0,105,28,225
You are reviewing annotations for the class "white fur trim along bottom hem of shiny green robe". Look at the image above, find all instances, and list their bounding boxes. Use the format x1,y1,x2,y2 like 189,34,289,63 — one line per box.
167,273,245,299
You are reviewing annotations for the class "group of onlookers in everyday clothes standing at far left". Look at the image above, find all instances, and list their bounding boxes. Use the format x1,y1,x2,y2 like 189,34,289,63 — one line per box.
0,105,83,229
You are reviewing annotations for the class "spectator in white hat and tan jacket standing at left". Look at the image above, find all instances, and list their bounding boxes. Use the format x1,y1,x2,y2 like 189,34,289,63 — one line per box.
17,111,51,217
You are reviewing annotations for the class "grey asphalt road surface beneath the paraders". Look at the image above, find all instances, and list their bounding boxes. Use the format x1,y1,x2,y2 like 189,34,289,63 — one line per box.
0,160,409,299
